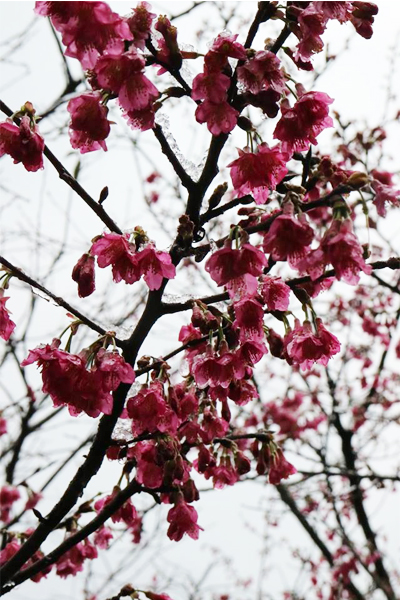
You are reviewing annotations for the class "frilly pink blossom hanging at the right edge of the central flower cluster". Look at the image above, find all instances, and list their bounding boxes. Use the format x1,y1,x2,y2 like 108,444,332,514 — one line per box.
285,318,340,371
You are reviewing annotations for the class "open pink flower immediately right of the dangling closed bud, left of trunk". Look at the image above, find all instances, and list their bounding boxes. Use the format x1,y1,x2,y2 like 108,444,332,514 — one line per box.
90,233,140,283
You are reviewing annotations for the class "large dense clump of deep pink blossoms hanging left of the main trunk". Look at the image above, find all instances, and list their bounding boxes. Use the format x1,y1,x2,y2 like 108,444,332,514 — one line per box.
21,339,135,417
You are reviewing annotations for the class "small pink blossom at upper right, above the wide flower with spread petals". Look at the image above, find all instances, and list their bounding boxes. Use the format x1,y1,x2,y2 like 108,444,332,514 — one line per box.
237,50,286,94
